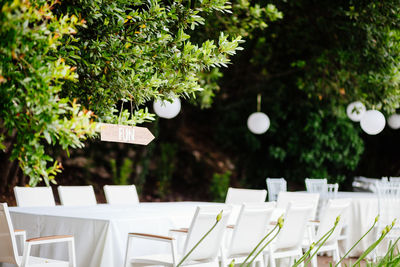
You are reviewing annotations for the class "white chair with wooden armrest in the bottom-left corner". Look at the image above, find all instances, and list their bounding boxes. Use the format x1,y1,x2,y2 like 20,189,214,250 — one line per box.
0,203,76,267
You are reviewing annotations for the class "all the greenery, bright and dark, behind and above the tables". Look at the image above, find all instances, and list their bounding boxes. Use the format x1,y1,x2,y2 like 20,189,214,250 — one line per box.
0,0,400,204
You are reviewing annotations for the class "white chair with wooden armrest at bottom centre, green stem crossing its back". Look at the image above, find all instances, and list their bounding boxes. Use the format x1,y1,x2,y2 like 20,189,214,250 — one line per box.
125,206,230,267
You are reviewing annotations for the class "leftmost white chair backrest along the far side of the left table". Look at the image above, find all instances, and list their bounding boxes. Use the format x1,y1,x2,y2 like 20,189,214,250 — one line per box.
14,186,56,207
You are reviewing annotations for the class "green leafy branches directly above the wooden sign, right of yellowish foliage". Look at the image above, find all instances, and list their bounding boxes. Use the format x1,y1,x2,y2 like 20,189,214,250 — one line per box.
56,0,241,120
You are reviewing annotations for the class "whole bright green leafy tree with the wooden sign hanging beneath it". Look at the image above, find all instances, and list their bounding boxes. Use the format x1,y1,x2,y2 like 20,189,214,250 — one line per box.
0,0,241,186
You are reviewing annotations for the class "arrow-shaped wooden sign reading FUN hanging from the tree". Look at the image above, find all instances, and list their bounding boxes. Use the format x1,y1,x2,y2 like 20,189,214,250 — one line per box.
100,123,154,145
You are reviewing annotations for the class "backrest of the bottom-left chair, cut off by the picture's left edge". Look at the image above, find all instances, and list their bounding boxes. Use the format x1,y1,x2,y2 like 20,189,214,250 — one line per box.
0,203,19,265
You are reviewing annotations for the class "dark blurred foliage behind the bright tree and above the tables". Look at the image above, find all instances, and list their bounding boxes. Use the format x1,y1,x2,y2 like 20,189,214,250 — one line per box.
0,0,400,205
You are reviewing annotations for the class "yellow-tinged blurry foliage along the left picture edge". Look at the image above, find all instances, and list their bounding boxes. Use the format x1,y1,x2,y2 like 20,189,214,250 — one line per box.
0,1,94,185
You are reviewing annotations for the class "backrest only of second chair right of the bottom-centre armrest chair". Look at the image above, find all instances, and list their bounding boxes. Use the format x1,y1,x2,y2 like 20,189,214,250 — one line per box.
274,203,313,249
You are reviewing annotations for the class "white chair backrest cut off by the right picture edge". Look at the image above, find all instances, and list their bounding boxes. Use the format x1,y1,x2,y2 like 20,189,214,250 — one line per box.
375,181,400,226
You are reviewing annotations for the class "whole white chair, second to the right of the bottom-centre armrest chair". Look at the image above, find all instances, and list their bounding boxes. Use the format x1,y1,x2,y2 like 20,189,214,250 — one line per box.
264,203,313,267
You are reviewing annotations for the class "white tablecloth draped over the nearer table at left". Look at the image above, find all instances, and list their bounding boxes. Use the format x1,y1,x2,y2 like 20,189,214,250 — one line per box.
10,202,227,267
